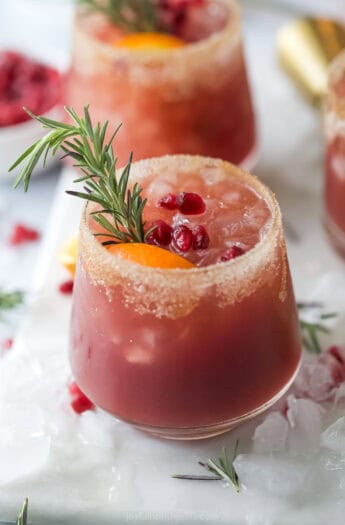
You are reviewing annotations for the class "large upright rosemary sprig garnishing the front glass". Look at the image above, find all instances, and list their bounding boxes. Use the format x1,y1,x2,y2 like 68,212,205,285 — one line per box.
9,106,148,244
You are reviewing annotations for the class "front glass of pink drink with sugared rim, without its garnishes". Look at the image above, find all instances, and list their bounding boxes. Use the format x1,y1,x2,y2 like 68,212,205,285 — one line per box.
70,156,301,439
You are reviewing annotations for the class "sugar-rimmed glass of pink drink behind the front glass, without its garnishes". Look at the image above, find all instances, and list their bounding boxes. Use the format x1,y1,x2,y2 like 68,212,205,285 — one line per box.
67,0,256,167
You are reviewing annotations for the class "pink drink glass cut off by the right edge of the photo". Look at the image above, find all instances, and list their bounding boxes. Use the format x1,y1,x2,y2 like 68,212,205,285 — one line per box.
325,51,345,256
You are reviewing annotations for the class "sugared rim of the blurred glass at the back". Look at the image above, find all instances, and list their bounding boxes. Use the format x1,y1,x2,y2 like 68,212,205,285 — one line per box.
76,0,240,62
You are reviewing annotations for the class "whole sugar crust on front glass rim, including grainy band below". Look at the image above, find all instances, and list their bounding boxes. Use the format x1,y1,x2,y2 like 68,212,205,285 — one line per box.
80,155,287,317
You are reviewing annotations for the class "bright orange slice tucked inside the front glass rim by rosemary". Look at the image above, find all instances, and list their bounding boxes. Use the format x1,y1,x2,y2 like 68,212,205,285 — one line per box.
107,242,194,269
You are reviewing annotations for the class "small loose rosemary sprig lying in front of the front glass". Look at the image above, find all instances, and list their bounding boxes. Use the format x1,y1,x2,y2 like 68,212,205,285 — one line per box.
172,439,240,492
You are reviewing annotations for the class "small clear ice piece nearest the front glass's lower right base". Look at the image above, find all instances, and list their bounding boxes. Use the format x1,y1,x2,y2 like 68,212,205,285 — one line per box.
253,412,289,453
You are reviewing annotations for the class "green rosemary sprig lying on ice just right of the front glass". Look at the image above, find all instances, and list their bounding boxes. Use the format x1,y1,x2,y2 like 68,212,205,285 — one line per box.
297,302,338,354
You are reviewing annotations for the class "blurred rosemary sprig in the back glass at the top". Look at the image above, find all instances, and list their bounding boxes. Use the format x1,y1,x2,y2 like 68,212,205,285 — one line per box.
78,0,164,33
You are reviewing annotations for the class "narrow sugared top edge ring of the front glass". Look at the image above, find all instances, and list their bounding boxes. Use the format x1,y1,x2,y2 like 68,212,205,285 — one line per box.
80,155,282,285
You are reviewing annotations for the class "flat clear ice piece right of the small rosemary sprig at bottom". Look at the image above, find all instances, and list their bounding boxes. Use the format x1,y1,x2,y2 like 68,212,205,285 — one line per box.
234,454,309,496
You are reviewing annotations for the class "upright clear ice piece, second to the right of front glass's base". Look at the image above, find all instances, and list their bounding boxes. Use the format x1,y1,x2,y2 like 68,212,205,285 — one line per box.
286,395,323,454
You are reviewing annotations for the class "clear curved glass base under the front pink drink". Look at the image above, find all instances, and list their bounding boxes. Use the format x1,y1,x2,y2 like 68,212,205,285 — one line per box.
132,361,301,440
